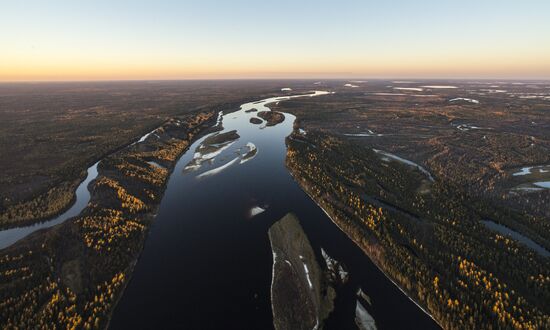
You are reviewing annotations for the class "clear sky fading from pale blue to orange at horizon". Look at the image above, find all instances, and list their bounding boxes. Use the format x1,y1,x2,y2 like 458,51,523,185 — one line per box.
0,0,550,81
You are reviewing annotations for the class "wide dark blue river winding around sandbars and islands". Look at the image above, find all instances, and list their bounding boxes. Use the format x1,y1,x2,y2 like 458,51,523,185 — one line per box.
110,92,437,329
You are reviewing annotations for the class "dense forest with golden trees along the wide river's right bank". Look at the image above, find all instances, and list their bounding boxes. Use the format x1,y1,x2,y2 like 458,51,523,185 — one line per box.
287,132,550,329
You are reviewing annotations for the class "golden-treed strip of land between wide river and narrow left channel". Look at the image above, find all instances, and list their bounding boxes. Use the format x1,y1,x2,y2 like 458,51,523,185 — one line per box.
0,111,217,328
